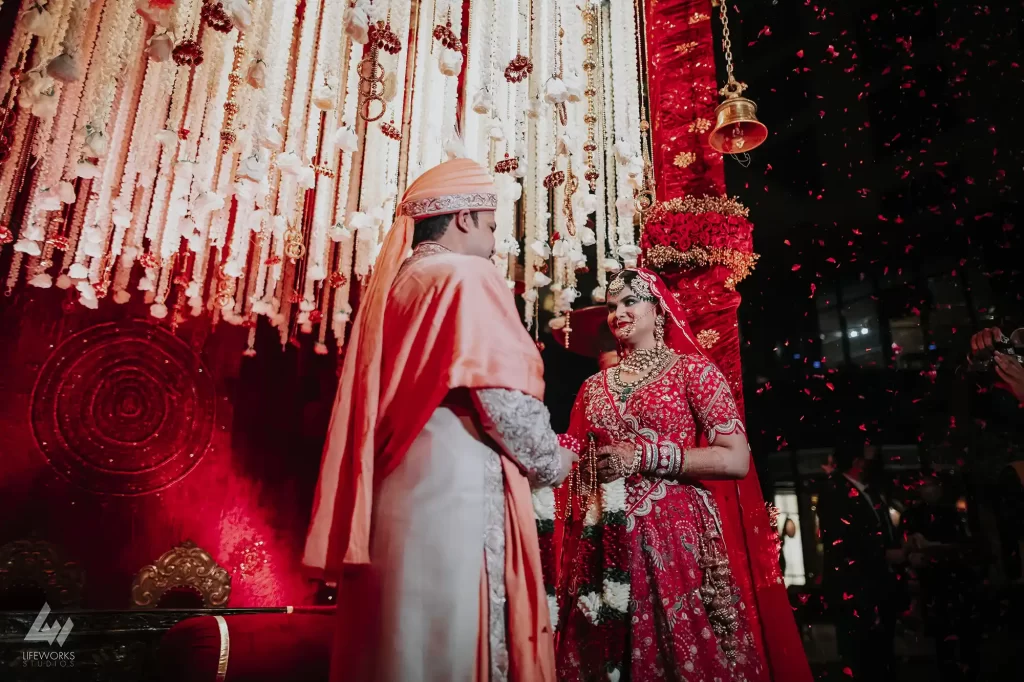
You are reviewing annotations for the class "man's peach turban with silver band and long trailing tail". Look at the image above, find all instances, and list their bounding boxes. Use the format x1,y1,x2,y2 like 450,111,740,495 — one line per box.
303,159,498,573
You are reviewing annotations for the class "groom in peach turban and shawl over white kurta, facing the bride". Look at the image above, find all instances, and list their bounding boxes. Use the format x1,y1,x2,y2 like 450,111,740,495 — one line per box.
304,159,572,682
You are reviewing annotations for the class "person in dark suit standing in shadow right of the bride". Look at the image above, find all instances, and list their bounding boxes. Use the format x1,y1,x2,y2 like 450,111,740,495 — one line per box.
817,440,908,682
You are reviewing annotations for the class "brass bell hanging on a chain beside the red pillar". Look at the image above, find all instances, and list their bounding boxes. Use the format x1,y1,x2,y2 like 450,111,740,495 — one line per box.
708,0,768,154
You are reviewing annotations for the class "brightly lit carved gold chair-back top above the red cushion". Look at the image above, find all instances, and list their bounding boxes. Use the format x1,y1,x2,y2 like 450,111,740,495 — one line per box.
131,540,231,608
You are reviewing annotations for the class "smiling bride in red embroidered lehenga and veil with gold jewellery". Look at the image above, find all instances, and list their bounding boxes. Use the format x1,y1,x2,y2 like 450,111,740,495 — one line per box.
538,269,811,682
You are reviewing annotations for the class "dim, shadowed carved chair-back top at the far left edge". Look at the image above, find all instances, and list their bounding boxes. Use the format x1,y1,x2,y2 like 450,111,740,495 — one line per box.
0,540,85,610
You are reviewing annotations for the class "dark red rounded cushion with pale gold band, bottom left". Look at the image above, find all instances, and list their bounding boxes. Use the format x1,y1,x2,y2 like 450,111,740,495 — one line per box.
158,609,335,682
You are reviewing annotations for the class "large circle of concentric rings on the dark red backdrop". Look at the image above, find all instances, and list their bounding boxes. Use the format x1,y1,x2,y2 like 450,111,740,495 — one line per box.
32,319,216,496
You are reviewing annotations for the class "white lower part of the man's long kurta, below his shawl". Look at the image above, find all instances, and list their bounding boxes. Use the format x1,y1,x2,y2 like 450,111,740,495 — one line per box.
367,408,504,682
